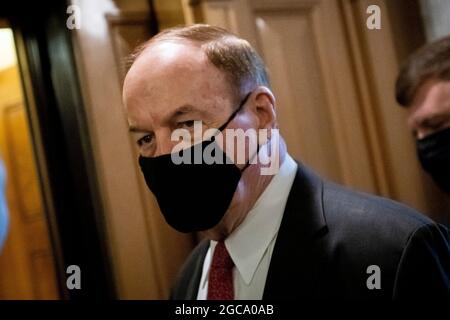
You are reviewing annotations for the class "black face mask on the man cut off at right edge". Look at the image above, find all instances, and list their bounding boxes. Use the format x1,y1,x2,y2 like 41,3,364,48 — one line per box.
417,128,450,194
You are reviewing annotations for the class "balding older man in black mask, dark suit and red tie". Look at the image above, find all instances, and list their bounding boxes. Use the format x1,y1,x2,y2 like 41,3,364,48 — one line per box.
123,25,450,299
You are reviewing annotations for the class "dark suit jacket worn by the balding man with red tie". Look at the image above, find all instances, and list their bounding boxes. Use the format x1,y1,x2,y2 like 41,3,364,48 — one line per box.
171,164,450,300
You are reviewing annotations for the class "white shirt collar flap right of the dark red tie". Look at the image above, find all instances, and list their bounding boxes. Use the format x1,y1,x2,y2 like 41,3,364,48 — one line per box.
223,154,297,285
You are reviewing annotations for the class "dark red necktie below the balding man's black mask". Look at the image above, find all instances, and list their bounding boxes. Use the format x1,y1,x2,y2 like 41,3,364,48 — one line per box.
208,241,234,300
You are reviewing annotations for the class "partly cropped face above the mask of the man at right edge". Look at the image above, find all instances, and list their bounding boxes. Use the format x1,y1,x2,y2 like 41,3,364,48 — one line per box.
408,79,450,139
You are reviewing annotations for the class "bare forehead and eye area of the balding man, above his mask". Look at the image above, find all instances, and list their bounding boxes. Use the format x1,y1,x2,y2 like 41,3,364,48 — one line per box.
123,42,255,157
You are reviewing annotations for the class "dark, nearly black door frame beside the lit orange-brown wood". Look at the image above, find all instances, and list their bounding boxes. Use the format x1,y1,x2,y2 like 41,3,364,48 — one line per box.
0,0,117,299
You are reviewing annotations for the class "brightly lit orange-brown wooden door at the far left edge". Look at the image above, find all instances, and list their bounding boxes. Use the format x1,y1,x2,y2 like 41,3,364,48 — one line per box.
0,65,59,299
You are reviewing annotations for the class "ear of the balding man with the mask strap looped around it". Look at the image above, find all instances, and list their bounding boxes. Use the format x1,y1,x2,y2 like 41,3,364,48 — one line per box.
253,86,277,129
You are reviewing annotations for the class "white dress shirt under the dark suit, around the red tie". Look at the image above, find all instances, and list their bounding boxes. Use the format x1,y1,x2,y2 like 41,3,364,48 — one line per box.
197,154,297,300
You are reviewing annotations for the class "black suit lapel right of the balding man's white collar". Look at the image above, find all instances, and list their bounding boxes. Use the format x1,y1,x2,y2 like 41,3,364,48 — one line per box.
263,164,326,300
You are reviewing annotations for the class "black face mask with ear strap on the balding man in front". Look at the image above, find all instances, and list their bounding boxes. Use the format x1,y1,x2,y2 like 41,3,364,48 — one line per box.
139,93,250,232
